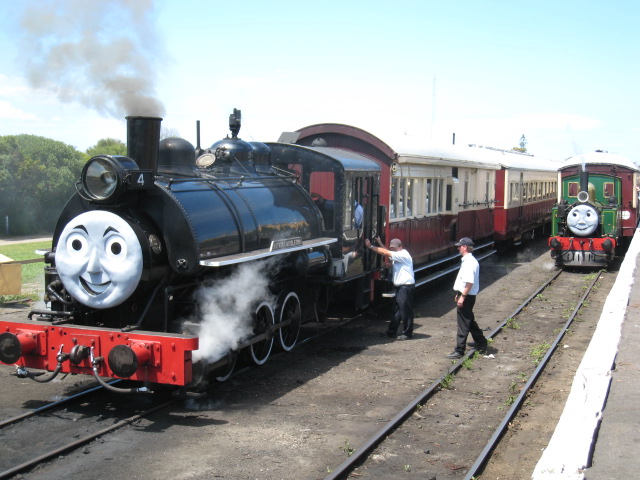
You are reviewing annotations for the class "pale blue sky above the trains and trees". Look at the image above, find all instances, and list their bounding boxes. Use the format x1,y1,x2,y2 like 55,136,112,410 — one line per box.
0,0,640,162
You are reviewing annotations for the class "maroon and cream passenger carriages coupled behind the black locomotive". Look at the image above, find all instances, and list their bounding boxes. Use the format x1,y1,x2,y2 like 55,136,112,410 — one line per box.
279,124,557,292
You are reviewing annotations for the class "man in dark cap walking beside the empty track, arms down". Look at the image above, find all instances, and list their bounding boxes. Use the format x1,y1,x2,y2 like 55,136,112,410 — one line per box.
447,237,487,359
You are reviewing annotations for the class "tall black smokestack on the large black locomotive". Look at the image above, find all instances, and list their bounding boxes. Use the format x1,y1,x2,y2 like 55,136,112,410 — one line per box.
125,117,162,172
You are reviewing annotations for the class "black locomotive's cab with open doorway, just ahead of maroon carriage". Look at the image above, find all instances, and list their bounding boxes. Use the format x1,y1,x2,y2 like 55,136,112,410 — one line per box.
268,139,382,309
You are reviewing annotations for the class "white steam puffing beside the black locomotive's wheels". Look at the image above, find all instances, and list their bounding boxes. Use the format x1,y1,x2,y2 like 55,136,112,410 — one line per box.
193,261,273,363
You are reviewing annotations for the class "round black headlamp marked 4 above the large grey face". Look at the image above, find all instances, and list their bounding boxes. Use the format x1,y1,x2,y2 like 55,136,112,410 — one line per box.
76,155,153,203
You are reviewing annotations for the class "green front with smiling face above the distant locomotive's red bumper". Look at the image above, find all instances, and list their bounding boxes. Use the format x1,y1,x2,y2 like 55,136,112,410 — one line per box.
551,173,622,238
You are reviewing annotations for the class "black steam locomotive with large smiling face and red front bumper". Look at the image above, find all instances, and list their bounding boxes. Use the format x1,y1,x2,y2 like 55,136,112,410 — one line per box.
0,110,380,389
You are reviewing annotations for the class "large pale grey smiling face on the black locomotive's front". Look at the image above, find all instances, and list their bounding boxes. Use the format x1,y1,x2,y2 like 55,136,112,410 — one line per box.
55,211,142,308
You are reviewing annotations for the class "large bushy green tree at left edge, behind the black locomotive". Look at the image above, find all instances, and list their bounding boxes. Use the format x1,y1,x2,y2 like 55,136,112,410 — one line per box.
0,135,87,235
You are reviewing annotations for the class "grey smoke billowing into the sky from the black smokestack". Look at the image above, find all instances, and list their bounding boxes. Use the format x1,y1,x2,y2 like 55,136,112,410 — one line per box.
20,0,164,118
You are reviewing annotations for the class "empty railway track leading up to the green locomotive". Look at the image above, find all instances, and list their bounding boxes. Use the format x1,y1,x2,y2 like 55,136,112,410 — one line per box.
325,271,604,480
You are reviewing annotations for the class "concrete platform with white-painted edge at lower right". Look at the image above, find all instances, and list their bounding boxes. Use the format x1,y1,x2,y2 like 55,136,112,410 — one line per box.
532,229,640,480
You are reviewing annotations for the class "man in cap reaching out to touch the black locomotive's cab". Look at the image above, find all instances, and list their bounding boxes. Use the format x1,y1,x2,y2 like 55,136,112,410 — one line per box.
364,237,416,340
